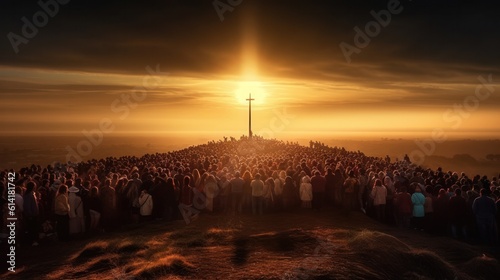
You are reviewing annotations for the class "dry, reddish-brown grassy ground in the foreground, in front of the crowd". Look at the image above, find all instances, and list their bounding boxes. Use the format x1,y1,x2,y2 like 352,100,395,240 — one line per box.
0,210,500,280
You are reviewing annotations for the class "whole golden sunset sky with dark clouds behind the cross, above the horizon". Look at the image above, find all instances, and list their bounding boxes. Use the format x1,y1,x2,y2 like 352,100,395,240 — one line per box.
0,0,500,137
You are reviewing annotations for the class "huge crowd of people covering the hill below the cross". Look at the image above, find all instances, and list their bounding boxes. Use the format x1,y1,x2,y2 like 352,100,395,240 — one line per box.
0,137,500,245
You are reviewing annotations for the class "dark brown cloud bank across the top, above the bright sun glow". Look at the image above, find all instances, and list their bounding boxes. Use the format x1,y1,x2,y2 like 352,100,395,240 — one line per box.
0,0,500,78
